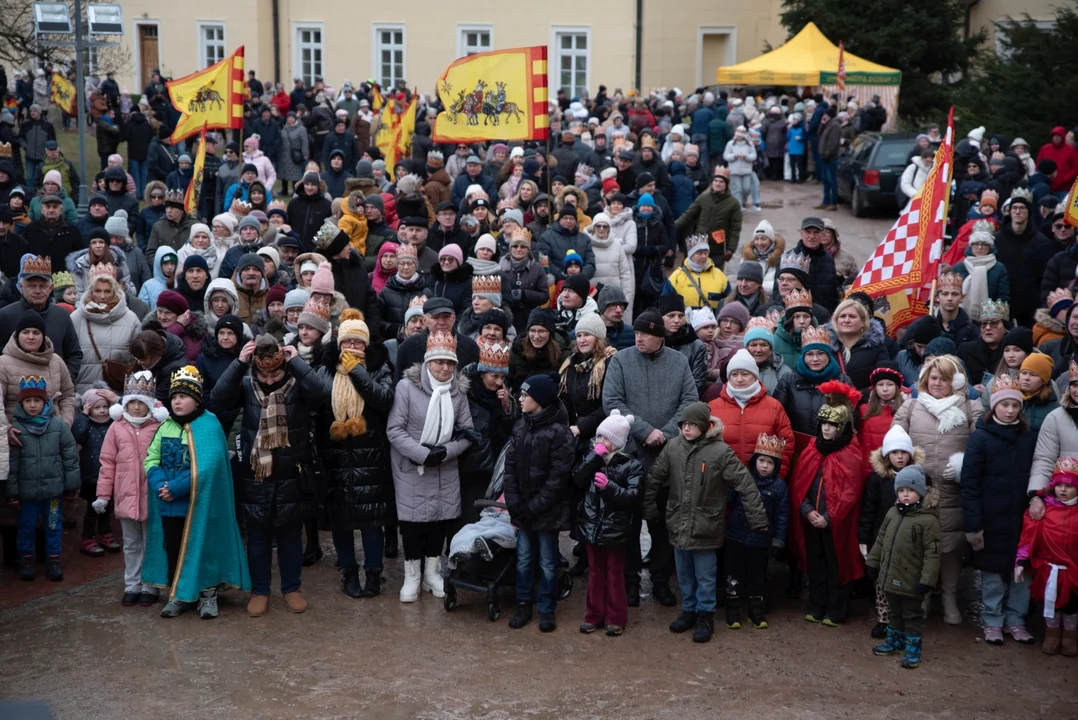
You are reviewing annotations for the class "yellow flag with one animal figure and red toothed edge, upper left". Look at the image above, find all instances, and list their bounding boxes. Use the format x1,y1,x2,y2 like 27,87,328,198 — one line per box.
165,45,247,142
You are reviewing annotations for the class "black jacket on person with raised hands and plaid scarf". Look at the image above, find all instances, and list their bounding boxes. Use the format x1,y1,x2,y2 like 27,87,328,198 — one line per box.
210,357,333,527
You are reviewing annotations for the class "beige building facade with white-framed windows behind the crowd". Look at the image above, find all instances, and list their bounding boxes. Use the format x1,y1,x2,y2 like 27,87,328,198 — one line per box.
118,0,1055,95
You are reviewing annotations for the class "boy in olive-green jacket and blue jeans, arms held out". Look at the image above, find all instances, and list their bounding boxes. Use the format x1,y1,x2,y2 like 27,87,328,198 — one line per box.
644,402,768,642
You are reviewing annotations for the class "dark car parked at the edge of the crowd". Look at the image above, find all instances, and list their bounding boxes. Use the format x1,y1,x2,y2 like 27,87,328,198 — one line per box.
838,133,916,218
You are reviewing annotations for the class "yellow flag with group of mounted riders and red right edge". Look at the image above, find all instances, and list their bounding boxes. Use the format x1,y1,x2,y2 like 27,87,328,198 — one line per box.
433,45,550,142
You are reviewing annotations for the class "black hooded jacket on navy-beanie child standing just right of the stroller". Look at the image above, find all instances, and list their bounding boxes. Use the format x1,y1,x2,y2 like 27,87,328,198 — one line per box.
502,401,576,532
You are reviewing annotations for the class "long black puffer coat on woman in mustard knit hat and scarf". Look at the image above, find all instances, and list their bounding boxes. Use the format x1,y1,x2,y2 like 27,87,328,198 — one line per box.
316,341,397,530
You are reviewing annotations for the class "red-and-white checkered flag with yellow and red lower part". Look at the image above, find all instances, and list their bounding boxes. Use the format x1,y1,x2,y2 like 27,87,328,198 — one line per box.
849,108,954,335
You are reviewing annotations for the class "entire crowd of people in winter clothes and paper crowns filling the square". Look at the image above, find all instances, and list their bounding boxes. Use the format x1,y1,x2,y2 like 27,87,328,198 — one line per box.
0,75,1078,667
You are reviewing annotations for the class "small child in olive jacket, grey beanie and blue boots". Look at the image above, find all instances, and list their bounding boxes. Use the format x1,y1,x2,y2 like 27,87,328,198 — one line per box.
866,465,940,668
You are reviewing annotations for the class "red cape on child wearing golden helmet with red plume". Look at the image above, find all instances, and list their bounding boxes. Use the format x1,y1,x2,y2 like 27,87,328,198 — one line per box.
786,435,866,585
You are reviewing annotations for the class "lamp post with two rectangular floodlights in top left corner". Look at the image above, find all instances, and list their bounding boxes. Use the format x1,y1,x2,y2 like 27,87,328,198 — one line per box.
33,0,124,213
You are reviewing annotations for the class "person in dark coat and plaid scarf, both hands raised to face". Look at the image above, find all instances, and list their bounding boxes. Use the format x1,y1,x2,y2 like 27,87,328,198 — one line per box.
209,335,333,617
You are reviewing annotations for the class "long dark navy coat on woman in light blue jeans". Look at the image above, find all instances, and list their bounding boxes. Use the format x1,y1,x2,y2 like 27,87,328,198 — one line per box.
962,418,1036,580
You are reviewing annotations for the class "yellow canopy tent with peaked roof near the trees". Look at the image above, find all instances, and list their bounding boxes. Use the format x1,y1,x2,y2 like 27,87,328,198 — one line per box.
717,23,902,129
